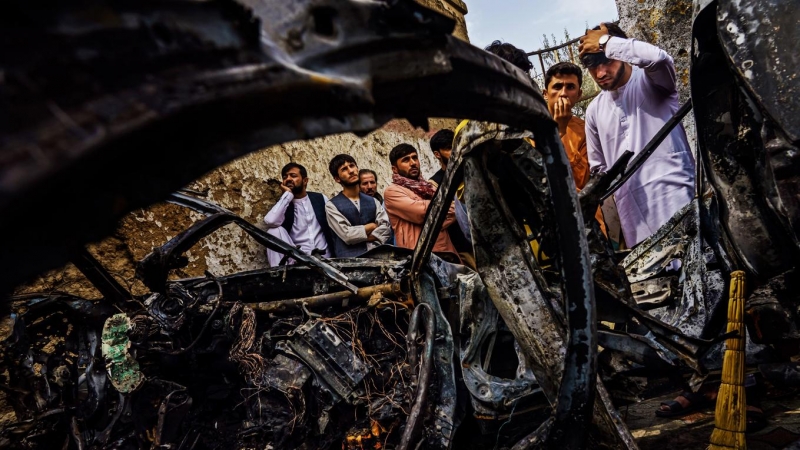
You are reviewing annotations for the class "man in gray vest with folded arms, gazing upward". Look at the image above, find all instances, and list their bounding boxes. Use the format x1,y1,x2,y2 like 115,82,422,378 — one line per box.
325,155,392,258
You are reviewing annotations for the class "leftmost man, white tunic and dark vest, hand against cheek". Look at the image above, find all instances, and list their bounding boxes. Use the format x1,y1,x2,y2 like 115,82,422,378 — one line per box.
264,163,331,267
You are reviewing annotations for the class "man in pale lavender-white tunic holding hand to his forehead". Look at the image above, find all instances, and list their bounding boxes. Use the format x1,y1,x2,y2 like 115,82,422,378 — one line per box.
580,23,694,247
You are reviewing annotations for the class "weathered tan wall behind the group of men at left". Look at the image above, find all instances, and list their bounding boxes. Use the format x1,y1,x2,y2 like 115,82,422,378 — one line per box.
18,0,467,298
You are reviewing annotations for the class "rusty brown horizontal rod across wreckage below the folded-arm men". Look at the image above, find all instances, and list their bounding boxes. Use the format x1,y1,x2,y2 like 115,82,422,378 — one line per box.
250,281,408,314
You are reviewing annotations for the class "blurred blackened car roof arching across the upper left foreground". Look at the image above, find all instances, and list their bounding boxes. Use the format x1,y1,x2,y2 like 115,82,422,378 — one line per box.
0,0,549,298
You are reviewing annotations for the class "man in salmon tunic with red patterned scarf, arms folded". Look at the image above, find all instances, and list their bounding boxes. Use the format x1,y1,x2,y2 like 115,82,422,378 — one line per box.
383,144,458,258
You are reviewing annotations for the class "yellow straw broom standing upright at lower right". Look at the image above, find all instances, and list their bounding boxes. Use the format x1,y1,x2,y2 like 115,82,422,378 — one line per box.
708,270,747,450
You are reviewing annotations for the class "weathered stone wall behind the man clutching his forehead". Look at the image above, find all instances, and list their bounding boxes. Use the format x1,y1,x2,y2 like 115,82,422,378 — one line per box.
616,0,696,149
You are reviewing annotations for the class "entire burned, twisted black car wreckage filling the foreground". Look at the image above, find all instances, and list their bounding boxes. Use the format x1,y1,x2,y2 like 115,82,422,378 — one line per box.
0,0,800,449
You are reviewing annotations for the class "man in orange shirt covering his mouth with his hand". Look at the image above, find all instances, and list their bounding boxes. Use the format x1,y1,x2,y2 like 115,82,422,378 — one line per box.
544,61,606,234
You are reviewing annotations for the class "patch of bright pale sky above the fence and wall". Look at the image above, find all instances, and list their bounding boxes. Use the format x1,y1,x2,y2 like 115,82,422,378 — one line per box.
464,0,619,52
